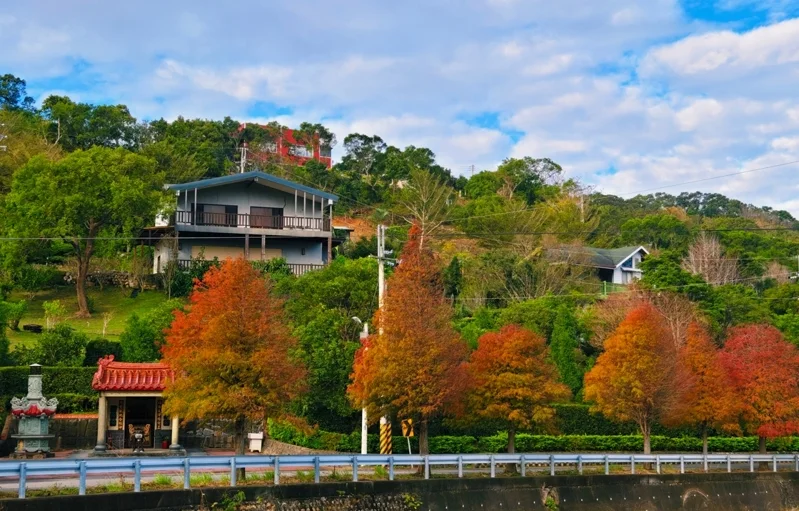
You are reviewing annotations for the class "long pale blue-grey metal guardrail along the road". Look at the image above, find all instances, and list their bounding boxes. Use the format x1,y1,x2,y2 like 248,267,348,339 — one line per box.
0,453,799,499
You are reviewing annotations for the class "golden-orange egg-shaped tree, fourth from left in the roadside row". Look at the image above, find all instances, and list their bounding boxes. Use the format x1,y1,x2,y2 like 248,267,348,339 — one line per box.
584,304,676,454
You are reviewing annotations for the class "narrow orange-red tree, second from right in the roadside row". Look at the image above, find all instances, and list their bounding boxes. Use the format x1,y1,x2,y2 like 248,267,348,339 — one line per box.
663,323,741,454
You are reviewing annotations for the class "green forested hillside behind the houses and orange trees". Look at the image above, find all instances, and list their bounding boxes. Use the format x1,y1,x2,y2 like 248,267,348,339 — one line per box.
0,75,799,432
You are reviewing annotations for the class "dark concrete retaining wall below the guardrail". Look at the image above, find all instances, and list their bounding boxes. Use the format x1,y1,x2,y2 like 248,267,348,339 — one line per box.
0,472,799,511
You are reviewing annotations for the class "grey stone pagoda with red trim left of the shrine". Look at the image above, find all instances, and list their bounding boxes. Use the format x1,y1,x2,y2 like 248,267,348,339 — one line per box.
11,364,58,458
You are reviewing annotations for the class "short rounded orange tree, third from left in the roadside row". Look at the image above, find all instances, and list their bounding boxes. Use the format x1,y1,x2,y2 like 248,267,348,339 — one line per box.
468,325,571,453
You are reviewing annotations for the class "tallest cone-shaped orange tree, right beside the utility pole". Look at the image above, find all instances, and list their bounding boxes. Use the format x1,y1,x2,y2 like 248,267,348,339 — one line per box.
348,225,467,454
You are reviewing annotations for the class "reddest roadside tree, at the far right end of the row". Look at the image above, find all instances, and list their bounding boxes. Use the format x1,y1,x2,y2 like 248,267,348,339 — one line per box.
721,325,799,442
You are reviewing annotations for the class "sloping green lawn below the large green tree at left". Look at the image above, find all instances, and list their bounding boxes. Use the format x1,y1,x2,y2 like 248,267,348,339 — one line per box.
8,286,175,348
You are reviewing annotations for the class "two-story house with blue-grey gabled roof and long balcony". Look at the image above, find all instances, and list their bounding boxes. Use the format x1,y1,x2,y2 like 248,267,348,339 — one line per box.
148,171,338,275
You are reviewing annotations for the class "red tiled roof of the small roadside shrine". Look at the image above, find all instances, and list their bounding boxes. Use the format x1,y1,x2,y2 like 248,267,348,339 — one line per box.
92,355,175,392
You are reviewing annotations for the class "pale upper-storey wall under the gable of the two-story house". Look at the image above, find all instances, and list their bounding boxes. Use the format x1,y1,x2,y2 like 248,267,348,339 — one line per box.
177,183,324,218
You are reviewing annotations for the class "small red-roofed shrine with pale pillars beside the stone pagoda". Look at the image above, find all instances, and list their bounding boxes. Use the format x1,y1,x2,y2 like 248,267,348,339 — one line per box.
92,355,181,452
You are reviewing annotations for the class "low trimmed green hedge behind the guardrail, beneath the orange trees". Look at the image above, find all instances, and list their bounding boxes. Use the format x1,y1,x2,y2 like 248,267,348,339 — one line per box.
269,422,799,454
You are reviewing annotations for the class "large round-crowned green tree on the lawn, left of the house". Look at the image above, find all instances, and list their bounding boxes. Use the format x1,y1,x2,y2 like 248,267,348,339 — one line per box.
6,147,164,317
